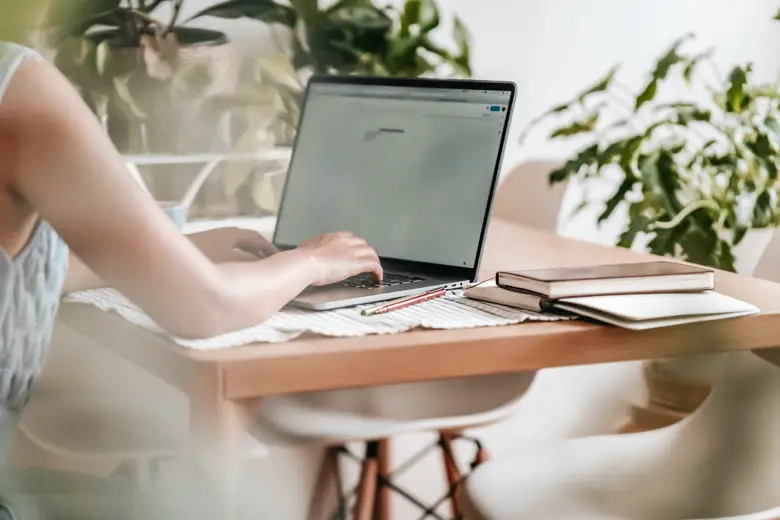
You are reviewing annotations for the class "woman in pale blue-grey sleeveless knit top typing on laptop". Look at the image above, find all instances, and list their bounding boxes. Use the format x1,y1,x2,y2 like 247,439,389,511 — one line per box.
0,36,382,520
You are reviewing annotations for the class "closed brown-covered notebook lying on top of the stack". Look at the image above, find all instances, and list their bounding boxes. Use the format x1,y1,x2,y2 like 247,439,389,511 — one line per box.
496,261,715,299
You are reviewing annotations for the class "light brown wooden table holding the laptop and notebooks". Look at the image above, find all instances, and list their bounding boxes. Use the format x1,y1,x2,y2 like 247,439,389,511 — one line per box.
61,220,780,516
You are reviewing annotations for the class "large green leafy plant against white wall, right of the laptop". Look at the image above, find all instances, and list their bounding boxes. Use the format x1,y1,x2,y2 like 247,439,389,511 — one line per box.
531,29,780,271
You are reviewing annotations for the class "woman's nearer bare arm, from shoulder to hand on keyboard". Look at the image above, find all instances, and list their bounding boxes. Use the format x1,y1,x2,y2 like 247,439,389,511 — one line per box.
0,61,381,337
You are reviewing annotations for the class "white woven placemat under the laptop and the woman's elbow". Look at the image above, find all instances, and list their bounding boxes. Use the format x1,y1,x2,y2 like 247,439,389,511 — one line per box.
65,289,568,350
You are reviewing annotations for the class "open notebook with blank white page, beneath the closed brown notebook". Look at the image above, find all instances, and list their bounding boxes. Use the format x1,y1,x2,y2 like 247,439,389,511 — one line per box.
464,283,759,330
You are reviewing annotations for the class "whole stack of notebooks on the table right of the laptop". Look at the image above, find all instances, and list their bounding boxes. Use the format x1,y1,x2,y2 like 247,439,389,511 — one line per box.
465,261,759,330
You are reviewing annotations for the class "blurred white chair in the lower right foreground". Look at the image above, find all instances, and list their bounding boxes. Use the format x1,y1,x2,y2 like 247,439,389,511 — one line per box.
464,232,780,520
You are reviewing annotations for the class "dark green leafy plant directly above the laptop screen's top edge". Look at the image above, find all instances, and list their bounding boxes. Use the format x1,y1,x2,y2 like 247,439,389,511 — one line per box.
194,0,471,77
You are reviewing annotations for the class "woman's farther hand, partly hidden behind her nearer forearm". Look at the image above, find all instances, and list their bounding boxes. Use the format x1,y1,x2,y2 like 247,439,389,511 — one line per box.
187,227,279,264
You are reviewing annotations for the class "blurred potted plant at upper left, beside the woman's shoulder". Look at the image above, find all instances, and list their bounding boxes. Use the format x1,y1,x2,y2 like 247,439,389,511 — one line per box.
48,0,241,152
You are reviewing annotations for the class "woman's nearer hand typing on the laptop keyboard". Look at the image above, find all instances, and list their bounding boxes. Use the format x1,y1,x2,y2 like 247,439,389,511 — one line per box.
298,231,383,285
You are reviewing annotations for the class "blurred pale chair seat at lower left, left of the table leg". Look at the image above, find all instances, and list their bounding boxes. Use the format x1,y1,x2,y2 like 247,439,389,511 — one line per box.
19,390,267,458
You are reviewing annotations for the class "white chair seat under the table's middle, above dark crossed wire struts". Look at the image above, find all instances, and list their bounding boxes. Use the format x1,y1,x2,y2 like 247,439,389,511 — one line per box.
253,373,535,444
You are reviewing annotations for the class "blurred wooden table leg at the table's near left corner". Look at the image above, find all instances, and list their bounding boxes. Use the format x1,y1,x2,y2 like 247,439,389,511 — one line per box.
190,370,251,520
